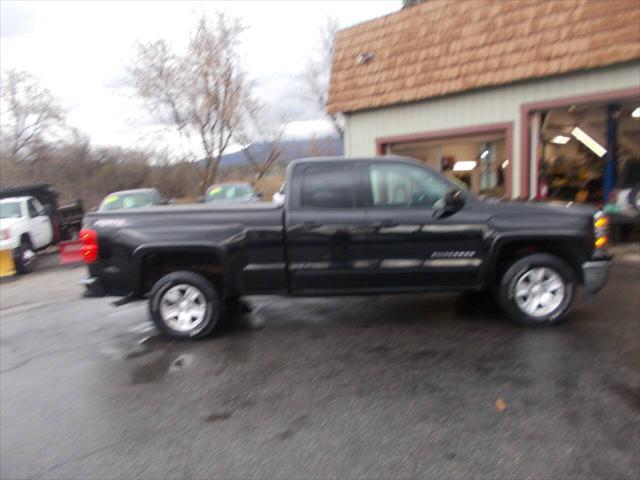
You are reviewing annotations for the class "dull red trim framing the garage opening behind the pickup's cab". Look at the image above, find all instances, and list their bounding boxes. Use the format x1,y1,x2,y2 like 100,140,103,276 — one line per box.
376,122,513,198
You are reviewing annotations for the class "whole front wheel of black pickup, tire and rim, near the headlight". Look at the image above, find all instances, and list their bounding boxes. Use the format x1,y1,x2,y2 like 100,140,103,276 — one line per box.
497,253,576,325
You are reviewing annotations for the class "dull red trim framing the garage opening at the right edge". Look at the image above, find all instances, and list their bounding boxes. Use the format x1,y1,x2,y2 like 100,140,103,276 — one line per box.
519,87,640,199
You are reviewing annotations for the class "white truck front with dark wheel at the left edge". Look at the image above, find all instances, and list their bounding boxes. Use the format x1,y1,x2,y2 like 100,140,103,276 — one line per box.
0,197,53,273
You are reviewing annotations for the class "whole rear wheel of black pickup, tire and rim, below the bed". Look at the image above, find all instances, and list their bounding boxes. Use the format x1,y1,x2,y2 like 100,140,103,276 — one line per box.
149,271,220,339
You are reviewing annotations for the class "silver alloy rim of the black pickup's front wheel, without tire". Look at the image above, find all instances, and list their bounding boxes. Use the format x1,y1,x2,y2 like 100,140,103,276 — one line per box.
513,267,566,318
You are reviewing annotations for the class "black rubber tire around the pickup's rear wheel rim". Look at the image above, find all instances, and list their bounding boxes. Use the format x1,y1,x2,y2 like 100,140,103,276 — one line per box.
149,271,220,340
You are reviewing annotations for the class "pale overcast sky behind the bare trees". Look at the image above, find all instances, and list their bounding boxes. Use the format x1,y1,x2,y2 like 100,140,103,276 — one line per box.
0,0,400,156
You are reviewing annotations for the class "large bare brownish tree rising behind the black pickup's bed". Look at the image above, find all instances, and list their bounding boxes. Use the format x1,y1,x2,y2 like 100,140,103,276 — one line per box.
130,13,252,193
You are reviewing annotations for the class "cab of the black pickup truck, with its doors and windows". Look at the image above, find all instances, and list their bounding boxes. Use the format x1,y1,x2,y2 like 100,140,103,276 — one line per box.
286,158,488,293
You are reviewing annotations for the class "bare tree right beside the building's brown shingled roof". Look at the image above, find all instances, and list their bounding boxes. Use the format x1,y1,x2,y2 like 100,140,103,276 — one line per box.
302,17,344,137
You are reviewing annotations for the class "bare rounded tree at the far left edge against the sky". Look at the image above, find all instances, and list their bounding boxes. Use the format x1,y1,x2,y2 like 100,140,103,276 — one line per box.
1,70,65,161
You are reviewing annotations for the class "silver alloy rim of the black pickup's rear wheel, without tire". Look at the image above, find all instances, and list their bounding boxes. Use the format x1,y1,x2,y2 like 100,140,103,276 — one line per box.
160,283,207,333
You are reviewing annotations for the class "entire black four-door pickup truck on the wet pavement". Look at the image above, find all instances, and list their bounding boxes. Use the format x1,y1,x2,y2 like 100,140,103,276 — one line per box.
81,157,611,338
